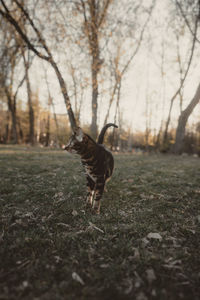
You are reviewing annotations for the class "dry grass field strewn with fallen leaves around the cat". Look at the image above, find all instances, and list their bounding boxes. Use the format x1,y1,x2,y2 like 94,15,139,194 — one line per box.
0,146,200,300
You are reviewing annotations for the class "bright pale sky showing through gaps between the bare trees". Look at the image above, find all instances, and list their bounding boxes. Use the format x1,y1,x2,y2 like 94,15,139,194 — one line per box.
16,0,200,131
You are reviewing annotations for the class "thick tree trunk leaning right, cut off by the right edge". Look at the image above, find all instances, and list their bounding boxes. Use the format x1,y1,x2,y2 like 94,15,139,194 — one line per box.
172,84,200,154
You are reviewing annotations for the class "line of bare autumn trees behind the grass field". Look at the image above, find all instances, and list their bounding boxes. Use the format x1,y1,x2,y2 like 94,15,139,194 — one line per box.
0,0,200,153
